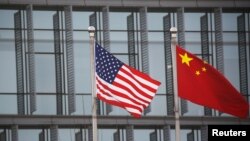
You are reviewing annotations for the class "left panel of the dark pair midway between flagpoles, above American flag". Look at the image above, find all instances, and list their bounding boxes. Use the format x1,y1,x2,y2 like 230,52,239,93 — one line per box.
127,13,136,68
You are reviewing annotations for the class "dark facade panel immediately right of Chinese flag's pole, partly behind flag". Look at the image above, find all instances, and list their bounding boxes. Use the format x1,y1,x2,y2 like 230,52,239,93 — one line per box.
177,7,188,115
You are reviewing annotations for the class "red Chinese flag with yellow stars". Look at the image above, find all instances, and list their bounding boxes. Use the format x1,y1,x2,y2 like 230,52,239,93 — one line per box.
176,46,249,118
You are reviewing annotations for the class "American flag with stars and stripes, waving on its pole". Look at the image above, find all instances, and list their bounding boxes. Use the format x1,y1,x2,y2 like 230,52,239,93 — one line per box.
95,44,161,118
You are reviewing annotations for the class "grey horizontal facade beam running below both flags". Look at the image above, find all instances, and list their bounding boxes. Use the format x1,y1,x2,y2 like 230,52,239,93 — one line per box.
0,115,250,128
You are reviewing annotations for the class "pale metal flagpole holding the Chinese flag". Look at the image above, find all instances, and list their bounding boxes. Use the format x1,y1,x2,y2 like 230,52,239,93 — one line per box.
170,27,180,141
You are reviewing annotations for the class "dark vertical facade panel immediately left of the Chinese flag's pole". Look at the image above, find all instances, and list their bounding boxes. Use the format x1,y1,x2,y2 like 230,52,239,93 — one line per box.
163,14,174,115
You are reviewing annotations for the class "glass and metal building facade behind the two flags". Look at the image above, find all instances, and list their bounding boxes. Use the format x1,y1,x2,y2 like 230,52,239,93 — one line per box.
0,0,250,141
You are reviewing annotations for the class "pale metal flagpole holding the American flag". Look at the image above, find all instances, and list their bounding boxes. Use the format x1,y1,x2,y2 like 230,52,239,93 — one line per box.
88,26,97,141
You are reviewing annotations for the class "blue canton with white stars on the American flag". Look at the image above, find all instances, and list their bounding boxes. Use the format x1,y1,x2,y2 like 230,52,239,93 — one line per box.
95,43,123,84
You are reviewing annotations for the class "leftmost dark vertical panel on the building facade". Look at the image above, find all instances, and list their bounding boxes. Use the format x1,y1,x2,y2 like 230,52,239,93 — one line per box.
14,11,25,115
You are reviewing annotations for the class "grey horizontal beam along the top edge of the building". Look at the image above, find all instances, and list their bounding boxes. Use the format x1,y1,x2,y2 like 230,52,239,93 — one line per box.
0,0,250,8
